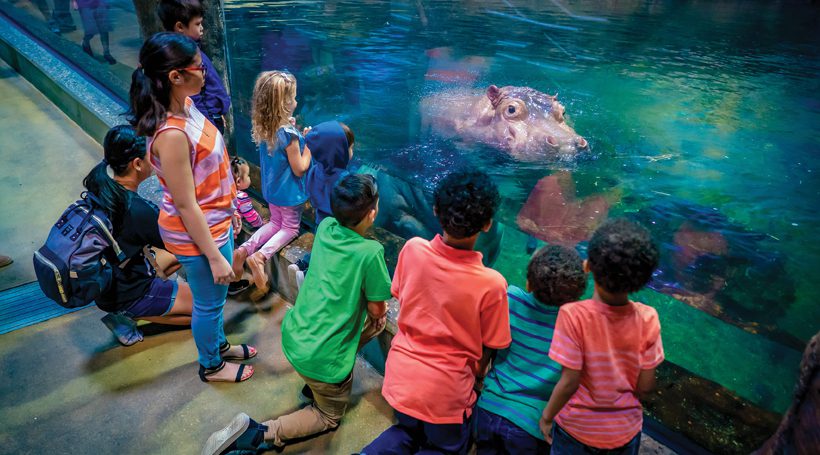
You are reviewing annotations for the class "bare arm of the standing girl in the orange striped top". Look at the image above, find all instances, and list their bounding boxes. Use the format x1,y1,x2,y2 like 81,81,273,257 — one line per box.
153,129,234,284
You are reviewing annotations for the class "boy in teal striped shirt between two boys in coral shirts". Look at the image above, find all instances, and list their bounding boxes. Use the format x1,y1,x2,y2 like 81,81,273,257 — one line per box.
475,245,586,455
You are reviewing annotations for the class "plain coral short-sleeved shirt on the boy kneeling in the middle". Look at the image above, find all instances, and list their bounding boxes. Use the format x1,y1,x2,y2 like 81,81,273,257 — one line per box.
382,236,512,424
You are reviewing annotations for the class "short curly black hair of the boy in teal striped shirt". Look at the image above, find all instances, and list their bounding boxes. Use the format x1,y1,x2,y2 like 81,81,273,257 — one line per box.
527,245,587,306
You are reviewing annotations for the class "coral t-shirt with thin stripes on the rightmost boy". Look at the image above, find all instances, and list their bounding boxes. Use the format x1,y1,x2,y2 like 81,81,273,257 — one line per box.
549,300,663,449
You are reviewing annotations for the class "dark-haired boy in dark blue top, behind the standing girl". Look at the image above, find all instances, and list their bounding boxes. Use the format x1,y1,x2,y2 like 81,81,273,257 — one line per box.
157,0,231,134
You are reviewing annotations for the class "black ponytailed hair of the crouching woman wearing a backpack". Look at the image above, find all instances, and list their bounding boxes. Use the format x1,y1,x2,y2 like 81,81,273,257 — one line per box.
83,125,145,232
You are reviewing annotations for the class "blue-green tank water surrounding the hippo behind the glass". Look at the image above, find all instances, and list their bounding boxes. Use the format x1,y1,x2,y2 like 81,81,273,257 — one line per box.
225,0,820,412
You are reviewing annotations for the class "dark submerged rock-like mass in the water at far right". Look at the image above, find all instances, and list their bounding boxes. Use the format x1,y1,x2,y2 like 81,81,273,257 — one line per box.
628,198,804,349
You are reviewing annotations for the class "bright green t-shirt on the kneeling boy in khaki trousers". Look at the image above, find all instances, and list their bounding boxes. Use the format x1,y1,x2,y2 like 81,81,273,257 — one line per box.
282,217,390,383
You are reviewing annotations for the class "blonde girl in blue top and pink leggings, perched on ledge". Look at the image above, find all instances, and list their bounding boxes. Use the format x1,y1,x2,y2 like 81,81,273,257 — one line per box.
233,71,311,300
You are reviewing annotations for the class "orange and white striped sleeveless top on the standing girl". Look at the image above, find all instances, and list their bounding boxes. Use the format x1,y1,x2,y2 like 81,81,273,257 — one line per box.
148,98,236,256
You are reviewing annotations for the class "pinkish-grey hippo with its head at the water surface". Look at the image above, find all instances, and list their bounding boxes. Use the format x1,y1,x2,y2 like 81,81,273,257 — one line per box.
421,85,589,161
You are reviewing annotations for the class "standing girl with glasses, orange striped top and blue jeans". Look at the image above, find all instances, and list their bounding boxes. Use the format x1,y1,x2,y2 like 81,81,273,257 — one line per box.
129,33,256,382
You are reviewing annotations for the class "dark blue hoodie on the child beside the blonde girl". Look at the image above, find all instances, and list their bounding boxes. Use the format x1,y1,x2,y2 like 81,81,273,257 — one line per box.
305,121,350,226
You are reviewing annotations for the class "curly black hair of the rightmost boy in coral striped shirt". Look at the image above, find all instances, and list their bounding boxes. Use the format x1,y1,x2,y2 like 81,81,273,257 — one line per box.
587,218,660,294
